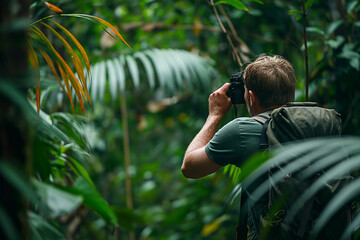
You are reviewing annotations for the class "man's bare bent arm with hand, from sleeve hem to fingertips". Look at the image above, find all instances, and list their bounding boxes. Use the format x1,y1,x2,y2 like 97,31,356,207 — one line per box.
181,83,231,178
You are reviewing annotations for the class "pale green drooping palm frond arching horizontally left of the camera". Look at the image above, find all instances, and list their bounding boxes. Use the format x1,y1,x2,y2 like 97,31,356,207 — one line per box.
89,49,219,101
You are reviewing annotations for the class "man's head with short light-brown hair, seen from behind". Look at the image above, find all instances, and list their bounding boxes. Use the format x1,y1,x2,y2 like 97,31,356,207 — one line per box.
244,55,296,112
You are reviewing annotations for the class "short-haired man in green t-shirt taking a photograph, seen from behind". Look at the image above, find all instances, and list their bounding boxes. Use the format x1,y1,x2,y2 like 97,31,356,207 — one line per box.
181,55,296,239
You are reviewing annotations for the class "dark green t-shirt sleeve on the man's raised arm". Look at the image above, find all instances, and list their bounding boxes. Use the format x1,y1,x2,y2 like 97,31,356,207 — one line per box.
205,118,262,166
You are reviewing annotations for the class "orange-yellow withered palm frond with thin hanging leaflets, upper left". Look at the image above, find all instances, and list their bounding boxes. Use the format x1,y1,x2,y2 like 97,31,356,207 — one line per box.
29,11,132,112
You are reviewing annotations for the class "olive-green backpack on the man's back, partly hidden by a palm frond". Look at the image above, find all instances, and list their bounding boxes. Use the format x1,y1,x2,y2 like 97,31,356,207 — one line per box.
237,102,353,240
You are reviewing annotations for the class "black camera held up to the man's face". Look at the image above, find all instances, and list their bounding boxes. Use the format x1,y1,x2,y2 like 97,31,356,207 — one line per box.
226,71,245,104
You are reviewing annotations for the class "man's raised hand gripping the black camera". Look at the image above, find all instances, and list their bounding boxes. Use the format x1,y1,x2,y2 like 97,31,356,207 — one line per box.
209,83,231,119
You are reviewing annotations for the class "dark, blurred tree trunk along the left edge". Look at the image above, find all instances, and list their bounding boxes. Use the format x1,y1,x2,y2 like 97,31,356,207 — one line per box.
0,0,30,239
